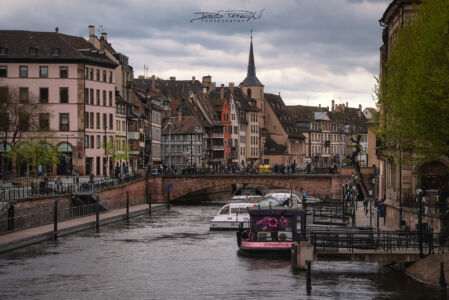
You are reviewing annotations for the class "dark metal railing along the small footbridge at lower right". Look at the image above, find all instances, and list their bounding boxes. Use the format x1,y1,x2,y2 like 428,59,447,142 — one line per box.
306,230,449,253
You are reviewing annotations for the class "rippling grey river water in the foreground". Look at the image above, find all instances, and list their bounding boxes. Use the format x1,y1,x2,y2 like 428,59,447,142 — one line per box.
0,194,445,299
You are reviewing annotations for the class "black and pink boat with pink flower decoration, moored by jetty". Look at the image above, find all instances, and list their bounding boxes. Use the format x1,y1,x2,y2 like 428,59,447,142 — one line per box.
237,206,307,254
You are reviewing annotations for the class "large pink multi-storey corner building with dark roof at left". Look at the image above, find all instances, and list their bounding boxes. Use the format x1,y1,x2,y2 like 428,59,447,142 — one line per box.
0,29,116,175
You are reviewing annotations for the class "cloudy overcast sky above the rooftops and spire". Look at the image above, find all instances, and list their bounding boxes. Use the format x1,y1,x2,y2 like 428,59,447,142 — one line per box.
0,0,390,107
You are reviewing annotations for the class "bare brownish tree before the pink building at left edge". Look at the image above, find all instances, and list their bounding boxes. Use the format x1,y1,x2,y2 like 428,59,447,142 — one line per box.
0,85,44,173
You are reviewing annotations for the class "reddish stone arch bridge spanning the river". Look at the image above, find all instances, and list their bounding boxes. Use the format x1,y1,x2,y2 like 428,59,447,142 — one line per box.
148,174,369,202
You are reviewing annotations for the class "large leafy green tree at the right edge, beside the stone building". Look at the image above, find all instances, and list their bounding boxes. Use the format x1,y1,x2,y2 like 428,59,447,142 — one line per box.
376,0,449,160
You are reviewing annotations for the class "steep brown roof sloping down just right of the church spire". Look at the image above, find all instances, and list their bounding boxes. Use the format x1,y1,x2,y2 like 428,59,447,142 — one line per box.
264,93,305,139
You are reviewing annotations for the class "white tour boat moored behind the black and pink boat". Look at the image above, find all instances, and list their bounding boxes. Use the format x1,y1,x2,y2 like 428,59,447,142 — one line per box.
210,198,283,230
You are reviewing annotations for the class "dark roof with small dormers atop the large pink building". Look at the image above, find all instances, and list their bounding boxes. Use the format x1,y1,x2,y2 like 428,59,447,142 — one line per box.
0,30,117,67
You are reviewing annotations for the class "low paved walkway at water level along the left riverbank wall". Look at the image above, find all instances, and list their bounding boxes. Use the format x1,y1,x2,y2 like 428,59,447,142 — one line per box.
0,204,166,253
